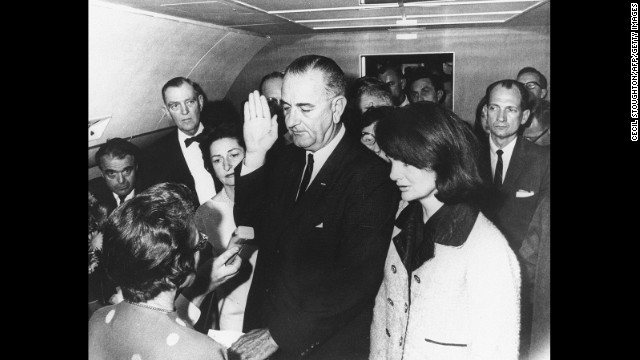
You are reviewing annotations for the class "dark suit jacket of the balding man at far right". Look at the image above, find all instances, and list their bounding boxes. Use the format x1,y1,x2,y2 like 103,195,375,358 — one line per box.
482,136,550,253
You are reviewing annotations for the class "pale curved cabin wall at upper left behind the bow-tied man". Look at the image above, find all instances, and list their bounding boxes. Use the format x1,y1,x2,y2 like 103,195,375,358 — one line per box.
88,3,270,178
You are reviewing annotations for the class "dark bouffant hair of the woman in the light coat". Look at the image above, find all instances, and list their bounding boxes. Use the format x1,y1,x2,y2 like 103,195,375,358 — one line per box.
376,101,483,204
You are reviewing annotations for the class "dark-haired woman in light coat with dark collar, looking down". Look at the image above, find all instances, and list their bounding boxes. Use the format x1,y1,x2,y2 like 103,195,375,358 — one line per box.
370,102,520,360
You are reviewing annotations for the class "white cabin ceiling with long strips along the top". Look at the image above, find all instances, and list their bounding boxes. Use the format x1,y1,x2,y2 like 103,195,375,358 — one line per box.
91,0,550,35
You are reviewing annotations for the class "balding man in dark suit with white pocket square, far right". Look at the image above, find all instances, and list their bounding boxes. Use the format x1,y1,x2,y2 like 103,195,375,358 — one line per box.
484,80,550,252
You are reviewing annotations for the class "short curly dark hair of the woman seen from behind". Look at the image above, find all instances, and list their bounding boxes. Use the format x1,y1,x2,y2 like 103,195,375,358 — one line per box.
101,183,197,302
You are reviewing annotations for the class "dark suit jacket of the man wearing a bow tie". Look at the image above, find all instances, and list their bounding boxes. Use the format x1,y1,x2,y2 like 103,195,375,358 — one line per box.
143,128,198,192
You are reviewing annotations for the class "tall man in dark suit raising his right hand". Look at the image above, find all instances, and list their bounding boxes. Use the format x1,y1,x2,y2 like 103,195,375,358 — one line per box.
229,55,398,359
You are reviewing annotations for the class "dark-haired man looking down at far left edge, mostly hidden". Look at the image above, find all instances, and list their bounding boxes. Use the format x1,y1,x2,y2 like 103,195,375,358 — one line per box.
89,138,141,214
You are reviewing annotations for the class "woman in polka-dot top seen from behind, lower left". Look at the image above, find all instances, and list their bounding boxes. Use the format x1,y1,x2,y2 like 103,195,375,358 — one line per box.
89,183,241,359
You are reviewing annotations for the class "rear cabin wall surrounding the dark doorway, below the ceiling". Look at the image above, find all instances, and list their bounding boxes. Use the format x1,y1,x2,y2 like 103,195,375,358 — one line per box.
228,26,552,122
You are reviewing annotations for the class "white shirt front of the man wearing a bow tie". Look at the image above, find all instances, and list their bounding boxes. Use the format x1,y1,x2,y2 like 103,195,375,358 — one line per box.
178,123,216,205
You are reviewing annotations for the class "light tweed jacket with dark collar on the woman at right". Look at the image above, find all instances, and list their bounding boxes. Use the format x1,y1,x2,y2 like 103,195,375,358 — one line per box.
369,213,520,360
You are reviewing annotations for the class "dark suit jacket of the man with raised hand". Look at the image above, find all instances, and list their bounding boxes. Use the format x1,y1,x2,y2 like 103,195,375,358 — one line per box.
234,135,399,359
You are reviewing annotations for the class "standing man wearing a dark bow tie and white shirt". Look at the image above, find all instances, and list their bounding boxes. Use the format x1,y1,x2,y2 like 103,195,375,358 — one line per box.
144,77,216,204
